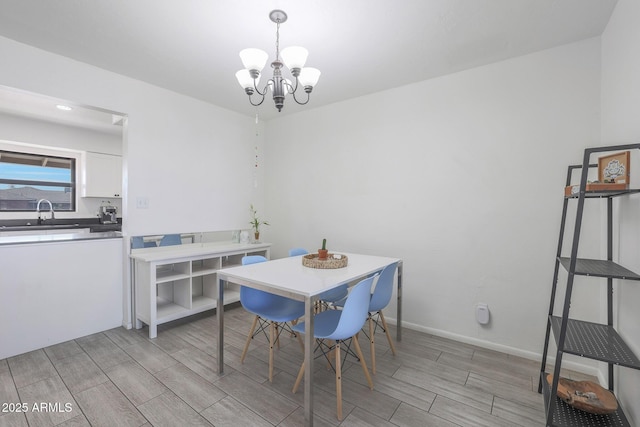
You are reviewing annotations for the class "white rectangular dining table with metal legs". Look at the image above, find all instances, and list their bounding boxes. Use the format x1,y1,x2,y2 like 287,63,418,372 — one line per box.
216,252,402,426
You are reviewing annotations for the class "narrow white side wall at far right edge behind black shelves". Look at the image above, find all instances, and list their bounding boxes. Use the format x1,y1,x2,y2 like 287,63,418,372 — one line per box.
602,0,640,425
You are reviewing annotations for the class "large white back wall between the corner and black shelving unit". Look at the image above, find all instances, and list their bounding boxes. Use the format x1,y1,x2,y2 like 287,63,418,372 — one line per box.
264,39,600,360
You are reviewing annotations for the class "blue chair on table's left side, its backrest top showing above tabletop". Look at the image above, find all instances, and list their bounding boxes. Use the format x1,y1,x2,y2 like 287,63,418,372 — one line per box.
240,255,304,382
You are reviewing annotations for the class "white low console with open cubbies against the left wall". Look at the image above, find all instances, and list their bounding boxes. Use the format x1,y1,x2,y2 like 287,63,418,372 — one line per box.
131,242,271,338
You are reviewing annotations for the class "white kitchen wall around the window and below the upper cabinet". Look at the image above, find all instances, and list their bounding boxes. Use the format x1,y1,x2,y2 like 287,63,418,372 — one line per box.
0,112,122,219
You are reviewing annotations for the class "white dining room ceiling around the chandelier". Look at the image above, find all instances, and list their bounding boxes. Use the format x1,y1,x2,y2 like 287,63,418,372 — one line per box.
0,0,617,124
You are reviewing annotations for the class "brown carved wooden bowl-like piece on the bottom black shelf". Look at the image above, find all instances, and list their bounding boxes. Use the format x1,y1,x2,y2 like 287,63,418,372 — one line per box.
547,374,618,415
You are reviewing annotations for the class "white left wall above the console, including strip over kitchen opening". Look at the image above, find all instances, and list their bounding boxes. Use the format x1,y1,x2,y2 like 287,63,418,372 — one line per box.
0,38,263,234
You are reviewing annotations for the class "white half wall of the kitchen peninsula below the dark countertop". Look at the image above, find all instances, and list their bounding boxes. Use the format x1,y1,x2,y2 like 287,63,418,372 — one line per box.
0,232,124,362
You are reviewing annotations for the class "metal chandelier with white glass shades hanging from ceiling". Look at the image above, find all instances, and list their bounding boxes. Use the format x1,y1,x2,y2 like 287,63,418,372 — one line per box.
236,10,320,112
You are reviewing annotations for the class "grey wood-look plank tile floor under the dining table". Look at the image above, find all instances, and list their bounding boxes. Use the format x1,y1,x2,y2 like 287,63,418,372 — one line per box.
0,306,592,427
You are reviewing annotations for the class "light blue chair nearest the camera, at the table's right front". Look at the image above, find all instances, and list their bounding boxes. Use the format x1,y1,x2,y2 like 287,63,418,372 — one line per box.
292,276,375,421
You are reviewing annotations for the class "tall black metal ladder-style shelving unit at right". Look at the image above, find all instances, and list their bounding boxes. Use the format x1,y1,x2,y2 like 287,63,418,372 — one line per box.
538,144,640,427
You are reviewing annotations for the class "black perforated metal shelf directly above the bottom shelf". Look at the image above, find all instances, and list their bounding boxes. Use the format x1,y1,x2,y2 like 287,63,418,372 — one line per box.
550,316,640,369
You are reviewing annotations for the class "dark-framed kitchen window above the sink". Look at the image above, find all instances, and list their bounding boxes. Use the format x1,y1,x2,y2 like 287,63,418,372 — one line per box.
0,150,76,212
